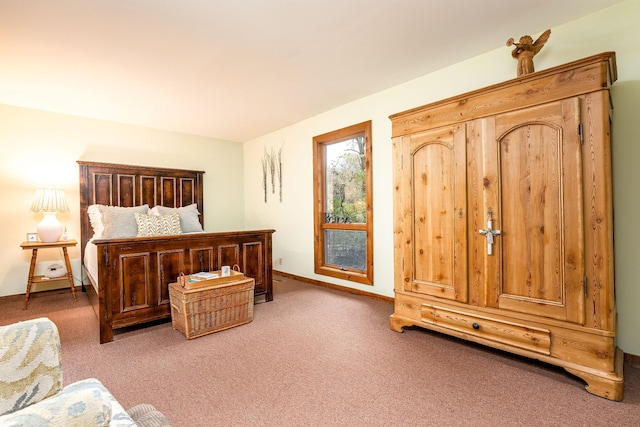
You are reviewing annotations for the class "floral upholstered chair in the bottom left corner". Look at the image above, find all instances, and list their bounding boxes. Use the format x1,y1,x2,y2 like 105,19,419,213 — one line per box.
0,318,169,427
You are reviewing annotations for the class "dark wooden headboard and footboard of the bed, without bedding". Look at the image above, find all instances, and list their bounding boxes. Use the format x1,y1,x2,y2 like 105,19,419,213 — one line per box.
78,161,274,343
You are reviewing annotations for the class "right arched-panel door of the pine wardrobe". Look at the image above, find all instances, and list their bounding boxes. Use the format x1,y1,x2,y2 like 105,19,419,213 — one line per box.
484,98,585,324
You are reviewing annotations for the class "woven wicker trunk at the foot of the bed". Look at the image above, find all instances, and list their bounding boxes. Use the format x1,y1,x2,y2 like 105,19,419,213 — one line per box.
169,278,255,339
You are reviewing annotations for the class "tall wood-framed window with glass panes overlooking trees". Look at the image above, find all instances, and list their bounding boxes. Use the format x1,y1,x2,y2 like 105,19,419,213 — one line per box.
313,121,373,285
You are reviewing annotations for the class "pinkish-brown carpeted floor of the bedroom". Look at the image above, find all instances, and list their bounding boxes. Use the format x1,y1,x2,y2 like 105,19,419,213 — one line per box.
0,278,640,427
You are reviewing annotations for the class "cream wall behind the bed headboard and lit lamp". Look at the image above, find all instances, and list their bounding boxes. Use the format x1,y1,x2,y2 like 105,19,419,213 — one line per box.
0,105,244,296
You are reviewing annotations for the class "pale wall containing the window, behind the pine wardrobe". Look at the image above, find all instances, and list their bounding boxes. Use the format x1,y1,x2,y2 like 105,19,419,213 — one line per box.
244,0,640,355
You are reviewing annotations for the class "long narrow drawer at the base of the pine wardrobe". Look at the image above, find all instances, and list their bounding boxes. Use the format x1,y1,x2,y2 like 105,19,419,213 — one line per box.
420,303,551,355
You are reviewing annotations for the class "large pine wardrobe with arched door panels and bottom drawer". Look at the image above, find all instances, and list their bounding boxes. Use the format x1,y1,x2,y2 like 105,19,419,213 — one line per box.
390,52,623,400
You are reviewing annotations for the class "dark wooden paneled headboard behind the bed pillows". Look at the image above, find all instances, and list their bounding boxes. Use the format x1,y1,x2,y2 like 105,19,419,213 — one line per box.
77,161,204,262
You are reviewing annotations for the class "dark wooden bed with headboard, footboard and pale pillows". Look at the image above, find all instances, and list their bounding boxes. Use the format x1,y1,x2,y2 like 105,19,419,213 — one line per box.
78,161,274,344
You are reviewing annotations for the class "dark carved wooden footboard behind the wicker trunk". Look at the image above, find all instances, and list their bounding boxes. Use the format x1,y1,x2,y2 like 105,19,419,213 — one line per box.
95,230,273,343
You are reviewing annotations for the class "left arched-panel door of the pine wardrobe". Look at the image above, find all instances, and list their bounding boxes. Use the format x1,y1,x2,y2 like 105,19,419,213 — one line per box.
401,124,468,302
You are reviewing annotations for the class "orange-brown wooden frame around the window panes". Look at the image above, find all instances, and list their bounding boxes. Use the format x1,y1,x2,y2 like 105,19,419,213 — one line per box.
313,120,373,285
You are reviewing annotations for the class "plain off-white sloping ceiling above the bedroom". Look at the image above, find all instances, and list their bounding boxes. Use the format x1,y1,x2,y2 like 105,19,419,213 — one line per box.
0,0,620,142
